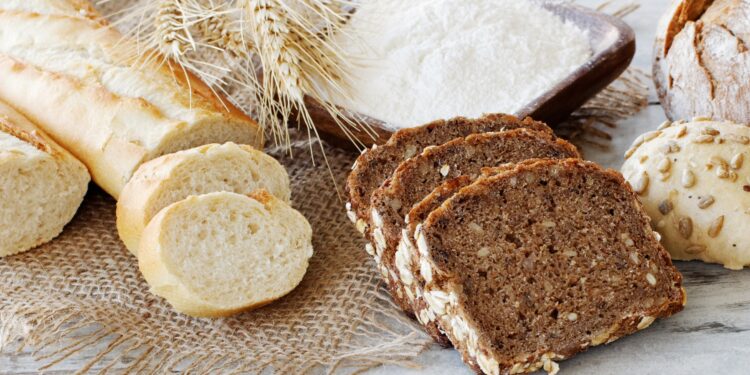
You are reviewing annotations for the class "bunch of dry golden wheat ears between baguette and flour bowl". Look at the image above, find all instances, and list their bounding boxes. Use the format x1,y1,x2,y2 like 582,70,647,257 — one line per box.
116,0,374,153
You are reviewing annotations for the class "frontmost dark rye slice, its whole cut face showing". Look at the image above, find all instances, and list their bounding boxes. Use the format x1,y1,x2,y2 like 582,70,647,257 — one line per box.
416,160,685,374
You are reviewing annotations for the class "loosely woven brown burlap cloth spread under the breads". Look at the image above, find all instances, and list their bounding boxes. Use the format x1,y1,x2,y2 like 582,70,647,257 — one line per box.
0,1,645,374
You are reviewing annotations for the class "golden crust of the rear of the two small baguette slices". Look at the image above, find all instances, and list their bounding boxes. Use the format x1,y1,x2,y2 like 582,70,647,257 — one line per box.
117,142,291,255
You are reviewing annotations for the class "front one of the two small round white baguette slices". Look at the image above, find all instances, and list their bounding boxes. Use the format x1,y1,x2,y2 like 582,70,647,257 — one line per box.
138,190,313,317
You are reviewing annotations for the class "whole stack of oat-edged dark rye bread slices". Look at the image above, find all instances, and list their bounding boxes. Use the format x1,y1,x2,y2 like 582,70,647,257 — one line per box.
347,115,685,374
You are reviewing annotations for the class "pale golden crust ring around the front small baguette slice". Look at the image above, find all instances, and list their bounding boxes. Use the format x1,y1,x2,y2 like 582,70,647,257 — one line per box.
138,190,313,318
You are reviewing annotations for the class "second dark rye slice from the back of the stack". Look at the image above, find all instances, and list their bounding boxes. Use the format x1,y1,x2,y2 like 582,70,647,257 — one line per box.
370,129,579,313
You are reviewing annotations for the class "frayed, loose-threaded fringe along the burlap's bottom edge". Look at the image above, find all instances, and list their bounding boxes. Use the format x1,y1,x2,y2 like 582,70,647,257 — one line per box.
0,300,431,374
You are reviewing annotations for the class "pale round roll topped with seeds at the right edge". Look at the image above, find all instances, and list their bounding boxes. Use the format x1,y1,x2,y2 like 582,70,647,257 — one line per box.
622,121,750,269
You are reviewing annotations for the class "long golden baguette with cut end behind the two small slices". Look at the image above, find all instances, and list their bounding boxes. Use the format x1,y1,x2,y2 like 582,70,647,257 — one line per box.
0,5,263,198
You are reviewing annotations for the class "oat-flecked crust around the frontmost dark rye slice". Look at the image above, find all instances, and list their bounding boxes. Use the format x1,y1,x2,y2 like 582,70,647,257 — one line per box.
416,159,686,375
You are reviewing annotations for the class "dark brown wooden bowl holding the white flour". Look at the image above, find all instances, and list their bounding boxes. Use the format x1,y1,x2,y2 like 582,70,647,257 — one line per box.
305,3,635,149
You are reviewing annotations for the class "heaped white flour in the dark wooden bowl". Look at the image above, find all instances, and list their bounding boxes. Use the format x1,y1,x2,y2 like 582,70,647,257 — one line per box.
334,0,591,129
